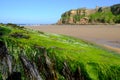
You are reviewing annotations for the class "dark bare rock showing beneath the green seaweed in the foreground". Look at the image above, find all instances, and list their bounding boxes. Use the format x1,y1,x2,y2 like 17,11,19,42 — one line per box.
0,41,87,80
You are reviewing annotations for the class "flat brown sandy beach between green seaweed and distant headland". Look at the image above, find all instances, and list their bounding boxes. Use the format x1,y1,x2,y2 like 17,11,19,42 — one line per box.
27,25,120,52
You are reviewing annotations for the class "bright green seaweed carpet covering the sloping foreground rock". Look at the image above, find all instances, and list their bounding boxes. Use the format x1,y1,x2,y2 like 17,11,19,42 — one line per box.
0,25,120,80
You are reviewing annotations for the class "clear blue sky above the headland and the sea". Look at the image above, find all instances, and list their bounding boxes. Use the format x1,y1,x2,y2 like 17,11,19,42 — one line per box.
0,0,120,24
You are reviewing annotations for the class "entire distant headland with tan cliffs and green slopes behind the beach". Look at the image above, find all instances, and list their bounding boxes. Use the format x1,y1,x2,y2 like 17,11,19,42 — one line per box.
57,4,120,24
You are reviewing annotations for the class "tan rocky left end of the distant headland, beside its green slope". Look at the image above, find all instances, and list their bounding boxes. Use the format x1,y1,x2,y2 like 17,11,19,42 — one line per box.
57,8,98,24
